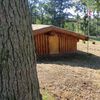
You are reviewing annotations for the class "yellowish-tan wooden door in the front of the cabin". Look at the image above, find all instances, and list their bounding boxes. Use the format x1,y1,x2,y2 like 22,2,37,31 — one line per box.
49,35,59,54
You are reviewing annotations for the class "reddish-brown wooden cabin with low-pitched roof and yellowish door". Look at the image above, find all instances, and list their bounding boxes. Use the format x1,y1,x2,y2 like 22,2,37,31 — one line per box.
32,25,88,56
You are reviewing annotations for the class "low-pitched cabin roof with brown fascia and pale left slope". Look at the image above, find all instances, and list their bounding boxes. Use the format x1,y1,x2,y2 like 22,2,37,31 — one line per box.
32,24,88,40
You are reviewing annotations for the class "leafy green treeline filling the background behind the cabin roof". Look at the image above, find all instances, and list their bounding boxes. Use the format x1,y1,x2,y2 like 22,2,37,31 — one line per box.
30,0,100,35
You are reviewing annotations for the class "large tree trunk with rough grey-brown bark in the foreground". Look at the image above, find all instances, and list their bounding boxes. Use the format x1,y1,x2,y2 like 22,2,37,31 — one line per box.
0,0,40,100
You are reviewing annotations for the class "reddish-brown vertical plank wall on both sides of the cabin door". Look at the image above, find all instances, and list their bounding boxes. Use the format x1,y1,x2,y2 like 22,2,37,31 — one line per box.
34,33,77,55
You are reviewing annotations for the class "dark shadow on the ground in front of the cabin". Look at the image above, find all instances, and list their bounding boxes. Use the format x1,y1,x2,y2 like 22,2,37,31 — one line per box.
37,51,100,69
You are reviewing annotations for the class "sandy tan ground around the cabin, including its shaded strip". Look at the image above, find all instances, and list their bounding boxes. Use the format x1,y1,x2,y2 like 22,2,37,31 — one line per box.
37,41,100,100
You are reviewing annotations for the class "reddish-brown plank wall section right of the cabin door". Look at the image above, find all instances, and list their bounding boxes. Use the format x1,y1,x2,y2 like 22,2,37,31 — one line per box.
58,34,77,54
